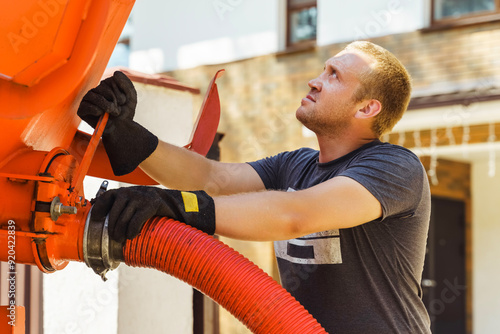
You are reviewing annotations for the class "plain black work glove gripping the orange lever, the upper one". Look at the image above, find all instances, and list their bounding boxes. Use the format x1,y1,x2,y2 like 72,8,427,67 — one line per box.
77,71,158,176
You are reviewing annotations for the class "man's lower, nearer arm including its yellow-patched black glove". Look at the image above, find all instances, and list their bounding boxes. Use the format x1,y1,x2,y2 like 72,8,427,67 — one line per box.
92,171,382,242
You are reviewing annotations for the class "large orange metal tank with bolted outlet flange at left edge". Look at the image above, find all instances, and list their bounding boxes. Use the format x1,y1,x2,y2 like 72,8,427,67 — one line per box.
0,0,134,272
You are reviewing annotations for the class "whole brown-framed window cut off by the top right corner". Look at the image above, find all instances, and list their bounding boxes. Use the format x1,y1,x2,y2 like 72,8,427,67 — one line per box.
431,0,500,28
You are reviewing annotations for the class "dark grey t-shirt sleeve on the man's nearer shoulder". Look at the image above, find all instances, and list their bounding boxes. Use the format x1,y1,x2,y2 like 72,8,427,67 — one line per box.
339,146,427,220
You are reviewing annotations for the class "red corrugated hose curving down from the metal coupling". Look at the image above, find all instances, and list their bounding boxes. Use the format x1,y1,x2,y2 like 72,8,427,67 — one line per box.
124,217,326,334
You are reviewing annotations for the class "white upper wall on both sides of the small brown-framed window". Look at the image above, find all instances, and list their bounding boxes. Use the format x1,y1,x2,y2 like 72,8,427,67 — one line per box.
130,0,427,73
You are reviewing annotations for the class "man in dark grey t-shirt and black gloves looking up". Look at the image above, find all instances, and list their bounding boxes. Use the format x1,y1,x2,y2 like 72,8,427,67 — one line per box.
79,42,430,334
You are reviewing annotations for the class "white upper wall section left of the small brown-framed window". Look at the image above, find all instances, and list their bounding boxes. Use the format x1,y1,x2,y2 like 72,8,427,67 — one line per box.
130,0,280,73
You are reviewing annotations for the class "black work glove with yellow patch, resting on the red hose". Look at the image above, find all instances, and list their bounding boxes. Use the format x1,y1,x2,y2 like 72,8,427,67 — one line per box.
92,186,215,242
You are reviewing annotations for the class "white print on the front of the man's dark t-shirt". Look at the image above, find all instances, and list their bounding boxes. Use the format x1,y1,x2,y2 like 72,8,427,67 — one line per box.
274,188,342,264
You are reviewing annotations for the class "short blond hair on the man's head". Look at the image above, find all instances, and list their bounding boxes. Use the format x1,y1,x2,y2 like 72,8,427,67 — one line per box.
345,41,411,137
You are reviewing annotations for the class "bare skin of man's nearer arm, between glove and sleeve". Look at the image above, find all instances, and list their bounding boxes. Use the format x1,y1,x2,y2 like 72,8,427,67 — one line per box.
214,176,382,241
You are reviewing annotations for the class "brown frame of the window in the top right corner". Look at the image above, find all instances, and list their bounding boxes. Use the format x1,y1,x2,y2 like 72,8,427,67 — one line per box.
430,0,500,30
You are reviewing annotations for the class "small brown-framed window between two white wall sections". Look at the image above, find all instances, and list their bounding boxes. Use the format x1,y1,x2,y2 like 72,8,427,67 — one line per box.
287,0,317,47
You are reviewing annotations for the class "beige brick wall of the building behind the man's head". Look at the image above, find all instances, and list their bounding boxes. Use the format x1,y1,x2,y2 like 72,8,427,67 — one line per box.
169,23,500,161
